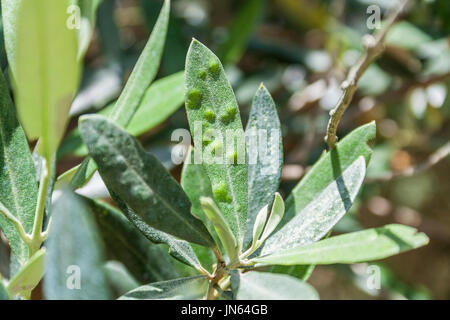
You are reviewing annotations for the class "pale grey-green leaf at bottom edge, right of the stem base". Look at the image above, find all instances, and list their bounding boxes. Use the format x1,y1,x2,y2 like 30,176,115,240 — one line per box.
233,272,319,300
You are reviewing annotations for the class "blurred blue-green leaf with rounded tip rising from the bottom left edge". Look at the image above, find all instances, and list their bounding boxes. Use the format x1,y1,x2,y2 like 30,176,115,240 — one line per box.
44,191,111,300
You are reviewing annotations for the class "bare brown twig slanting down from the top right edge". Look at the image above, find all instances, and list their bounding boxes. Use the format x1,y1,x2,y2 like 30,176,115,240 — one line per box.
325,0,409,149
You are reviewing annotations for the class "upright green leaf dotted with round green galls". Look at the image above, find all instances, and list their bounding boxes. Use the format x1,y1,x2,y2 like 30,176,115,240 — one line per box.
185,39,248,244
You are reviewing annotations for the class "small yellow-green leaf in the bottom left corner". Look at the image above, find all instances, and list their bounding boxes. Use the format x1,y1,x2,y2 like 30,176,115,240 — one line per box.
7,248,45,295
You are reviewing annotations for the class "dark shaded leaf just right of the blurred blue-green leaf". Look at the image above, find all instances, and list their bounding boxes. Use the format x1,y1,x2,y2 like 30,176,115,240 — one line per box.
85,199,178,283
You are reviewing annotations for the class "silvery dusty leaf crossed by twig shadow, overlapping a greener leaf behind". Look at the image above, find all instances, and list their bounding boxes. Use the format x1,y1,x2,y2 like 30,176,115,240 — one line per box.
261,157,366,255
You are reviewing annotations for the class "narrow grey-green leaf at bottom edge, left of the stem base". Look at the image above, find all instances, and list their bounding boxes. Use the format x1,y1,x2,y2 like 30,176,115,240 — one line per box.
119,276,208,300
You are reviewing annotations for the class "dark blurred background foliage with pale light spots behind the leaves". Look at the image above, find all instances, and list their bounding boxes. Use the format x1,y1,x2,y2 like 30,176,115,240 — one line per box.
0,0,450,299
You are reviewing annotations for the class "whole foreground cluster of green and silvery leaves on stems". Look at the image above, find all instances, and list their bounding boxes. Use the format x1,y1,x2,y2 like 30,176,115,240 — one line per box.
0,0,428,299
